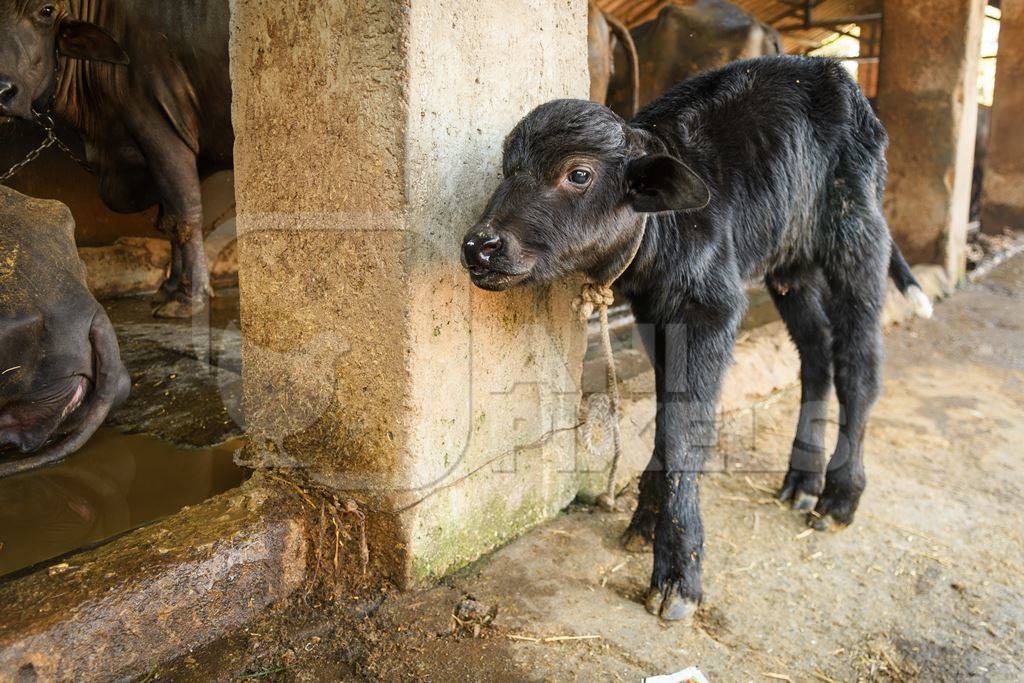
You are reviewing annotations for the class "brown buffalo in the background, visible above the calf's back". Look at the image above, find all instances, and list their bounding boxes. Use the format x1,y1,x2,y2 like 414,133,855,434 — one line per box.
608,0,784,118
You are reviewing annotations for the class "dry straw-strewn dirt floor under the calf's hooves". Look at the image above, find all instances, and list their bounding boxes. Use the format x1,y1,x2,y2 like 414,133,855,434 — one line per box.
151,255,1024,681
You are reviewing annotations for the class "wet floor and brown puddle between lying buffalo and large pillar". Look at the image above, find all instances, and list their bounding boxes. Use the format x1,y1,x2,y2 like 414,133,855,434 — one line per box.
0,290,246,577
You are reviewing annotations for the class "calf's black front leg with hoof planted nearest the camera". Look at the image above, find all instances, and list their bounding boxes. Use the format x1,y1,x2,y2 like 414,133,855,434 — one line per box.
645,315,738,621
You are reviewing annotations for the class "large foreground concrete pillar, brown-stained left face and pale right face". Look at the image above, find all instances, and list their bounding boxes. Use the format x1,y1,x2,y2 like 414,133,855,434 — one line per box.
231,0,588,585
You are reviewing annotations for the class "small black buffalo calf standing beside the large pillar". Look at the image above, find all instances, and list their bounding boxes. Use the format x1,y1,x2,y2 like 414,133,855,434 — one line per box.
463,57,928,620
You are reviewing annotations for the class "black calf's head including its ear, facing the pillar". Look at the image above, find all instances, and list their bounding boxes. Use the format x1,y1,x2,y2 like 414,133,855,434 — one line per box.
462,99,710,291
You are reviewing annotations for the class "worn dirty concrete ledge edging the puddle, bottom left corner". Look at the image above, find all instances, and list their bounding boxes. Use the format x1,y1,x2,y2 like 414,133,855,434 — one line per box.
0,475,312,681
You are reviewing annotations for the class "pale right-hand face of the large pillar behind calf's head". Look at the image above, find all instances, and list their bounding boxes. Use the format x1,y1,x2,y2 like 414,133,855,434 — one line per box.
406,0,590,575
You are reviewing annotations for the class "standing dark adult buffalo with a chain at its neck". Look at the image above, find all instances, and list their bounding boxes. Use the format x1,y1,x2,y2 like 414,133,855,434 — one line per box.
0,0,233,317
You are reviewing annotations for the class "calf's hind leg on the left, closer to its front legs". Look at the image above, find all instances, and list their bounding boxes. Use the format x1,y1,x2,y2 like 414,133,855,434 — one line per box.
765,270,833,512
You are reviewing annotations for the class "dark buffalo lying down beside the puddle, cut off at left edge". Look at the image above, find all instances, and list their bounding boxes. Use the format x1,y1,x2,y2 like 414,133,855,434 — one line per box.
0,185,130,477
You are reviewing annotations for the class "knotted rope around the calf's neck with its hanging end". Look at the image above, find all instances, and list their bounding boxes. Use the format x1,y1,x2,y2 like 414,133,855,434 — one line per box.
572,214,647,512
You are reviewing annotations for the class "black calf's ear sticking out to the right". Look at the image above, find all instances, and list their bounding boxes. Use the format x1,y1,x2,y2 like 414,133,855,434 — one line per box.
626,155,711,213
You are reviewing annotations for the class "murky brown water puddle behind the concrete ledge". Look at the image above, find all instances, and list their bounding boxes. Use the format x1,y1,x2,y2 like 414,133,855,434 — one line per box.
0,428,246,577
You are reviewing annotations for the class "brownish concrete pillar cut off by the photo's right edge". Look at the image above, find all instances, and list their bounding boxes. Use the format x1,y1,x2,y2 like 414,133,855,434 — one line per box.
981,0,1024,233
